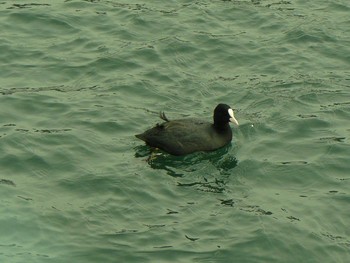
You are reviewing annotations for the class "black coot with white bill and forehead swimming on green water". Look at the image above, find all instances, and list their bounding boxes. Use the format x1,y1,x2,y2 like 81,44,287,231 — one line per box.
135,104,238,155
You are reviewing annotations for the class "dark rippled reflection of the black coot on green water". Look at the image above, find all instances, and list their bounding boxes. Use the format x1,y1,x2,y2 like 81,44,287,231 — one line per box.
135,144,238,193
